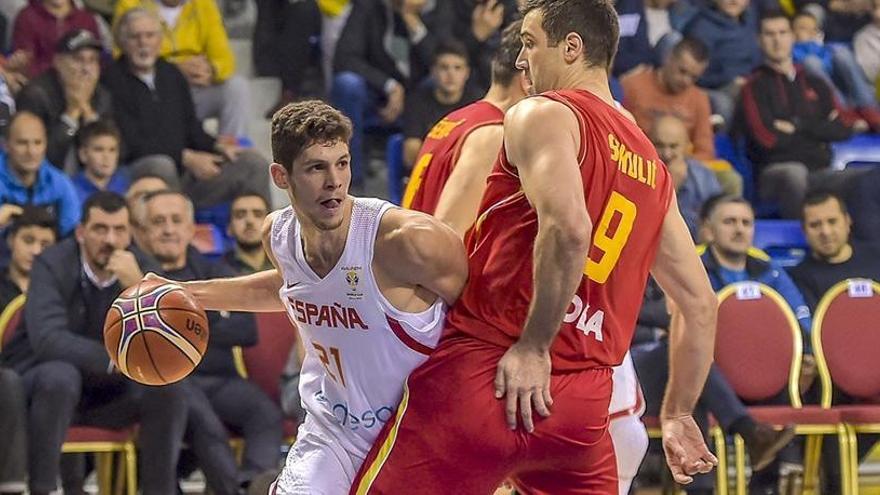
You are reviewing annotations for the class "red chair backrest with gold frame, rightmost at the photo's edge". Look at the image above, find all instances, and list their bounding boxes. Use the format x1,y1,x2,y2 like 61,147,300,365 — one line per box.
812,279,880,407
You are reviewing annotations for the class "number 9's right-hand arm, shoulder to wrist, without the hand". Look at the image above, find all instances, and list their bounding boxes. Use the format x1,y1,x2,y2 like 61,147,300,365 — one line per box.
652,201,718,418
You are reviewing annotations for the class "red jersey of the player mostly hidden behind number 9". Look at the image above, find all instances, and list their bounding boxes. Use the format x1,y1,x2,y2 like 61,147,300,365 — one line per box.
403,100,504,215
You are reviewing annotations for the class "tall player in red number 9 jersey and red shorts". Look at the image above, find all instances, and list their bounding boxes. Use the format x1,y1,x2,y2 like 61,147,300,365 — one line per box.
352,0,717,495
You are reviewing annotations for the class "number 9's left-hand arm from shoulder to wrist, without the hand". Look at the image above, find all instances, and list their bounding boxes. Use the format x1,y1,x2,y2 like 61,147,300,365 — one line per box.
504,98,592,351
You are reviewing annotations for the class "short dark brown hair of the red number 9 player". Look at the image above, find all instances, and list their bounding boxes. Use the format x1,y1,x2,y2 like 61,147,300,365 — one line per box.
522,0,620,70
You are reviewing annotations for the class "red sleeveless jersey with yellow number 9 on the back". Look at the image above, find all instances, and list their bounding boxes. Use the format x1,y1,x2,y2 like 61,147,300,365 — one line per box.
447,90,673,371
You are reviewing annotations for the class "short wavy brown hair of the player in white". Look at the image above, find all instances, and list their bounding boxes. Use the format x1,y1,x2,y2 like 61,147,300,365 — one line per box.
272,100,351,173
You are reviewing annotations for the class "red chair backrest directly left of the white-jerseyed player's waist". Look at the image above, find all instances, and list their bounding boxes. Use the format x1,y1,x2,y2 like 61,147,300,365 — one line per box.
242,312,297,403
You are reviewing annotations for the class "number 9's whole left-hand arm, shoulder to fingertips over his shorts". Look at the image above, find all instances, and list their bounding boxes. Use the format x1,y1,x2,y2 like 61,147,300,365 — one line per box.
495,98,592,431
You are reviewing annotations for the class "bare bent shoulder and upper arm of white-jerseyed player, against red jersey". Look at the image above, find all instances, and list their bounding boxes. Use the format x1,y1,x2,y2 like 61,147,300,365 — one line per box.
375,208,467,304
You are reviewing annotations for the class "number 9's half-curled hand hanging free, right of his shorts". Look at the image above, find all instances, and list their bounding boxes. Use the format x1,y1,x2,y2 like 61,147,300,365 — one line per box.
660,415,718,485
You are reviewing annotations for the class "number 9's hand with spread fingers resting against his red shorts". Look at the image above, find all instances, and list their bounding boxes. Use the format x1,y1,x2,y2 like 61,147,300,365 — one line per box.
495,344,553,433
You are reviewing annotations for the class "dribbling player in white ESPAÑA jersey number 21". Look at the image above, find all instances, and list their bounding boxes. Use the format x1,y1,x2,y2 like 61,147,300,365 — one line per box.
148,101,467,495
